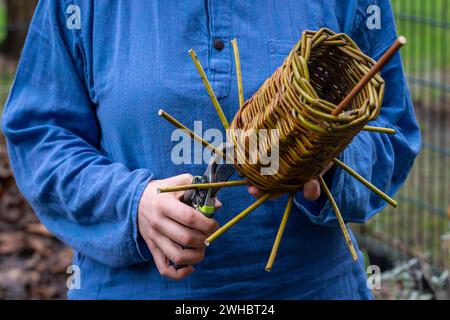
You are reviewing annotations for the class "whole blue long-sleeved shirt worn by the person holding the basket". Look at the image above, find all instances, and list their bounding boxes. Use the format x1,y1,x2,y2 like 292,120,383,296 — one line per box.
2,0,420,299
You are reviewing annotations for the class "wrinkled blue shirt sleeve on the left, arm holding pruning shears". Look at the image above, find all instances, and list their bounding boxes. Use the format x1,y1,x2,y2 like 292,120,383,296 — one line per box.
2,0,151,267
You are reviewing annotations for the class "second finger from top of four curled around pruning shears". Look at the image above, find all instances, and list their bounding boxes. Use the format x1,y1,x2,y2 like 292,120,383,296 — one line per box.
152,217,206,248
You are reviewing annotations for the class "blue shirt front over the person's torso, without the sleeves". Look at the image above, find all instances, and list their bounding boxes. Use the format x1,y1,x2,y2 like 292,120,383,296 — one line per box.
70,0,368,298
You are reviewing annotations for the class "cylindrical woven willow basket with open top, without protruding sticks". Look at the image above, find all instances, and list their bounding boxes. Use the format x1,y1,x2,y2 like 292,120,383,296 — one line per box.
228,29,384,193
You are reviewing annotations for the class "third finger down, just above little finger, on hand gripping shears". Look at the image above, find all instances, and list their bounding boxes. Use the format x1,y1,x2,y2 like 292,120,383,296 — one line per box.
153,230,205,265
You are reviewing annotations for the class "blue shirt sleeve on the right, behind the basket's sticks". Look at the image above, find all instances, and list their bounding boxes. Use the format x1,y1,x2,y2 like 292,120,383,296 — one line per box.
295,0,421,226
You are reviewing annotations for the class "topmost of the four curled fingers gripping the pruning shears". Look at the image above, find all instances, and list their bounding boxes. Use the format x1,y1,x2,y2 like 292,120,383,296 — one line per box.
160,201,219,234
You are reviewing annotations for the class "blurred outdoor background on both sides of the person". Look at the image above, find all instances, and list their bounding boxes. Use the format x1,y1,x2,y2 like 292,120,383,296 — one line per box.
0,0,450,299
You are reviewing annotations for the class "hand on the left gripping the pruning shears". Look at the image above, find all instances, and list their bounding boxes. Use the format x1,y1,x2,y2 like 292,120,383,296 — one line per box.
138,174,220,280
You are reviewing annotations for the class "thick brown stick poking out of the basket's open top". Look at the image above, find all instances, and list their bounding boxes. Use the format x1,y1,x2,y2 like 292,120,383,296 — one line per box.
331,36,406,116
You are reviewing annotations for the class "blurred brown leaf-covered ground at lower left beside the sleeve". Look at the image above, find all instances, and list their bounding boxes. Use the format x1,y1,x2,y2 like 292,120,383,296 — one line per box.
0,135,72,299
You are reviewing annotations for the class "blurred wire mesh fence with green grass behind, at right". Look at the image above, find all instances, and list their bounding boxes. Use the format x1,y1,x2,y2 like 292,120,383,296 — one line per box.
362,0,450,276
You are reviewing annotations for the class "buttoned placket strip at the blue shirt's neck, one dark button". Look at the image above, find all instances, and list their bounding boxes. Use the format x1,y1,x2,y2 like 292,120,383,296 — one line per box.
207,0,232,98
